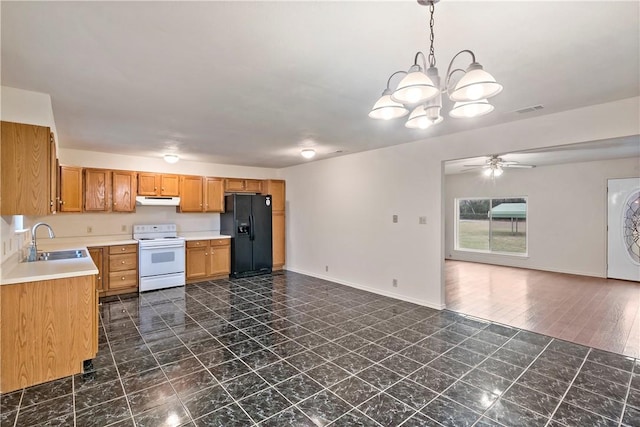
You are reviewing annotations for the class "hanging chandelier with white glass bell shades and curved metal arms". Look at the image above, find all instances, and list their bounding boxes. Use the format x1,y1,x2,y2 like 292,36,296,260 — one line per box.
369,0,502,129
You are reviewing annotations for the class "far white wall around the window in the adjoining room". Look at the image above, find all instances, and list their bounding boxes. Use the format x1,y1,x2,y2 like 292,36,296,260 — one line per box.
445,157,640,277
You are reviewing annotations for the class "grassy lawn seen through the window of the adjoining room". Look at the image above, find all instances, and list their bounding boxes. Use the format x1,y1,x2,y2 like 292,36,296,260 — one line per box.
458,220,527,253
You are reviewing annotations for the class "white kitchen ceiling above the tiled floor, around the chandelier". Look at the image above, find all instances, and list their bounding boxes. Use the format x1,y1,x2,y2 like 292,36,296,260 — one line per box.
1,0,640,168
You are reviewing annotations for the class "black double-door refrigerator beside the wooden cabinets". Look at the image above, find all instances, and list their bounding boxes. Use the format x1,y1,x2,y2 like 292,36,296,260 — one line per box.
220,194,273,277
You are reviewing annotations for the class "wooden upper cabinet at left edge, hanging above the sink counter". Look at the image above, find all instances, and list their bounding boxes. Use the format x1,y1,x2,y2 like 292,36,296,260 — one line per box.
0,122,56,215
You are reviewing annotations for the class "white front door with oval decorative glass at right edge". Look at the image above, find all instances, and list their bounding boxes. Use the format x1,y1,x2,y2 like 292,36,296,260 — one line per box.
607,178,640,282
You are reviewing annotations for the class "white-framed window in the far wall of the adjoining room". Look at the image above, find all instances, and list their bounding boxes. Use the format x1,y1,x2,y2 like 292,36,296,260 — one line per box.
455,197,527,255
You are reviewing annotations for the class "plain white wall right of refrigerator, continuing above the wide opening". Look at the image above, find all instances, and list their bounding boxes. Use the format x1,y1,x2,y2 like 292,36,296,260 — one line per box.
282,97,640,307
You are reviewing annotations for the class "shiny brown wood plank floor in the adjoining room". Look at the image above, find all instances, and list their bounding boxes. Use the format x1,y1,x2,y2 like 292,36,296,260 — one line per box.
445,260,640,358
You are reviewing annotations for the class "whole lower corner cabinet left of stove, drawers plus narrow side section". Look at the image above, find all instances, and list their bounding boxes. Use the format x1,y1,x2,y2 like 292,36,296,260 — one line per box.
89,244,138,296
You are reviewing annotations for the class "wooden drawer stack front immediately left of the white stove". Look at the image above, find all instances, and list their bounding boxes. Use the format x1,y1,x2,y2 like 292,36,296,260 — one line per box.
103,244,138,295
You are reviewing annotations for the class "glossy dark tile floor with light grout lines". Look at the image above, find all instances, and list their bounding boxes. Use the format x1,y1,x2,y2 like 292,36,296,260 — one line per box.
0,272,640,427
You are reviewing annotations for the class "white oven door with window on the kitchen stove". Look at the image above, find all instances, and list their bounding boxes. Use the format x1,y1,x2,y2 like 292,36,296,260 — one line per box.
138,242,185,277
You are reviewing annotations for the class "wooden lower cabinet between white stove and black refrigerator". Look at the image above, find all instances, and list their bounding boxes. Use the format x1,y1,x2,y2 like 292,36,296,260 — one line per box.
186,239,231,283
